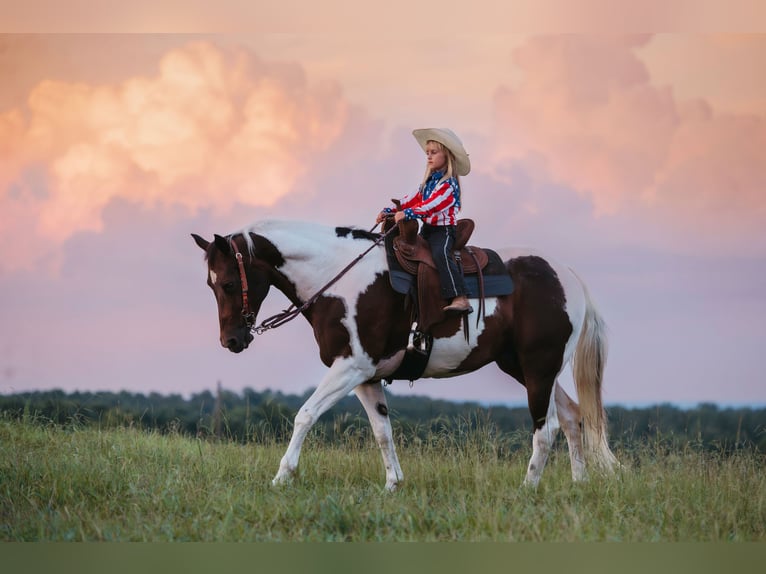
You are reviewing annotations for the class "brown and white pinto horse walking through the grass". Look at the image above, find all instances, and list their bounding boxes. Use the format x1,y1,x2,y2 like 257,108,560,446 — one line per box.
192,221,617,490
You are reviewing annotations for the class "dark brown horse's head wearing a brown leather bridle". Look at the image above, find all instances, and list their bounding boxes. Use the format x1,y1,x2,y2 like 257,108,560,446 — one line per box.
192,234,270,353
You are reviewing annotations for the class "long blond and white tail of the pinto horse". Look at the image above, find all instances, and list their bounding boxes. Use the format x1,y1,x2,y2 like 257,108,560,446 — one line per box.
572,271,619,471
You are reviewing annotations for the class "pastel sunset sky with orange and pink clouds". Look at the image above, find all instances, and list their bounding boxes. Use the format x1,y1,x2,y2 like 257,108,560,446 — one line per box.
0,30,766,405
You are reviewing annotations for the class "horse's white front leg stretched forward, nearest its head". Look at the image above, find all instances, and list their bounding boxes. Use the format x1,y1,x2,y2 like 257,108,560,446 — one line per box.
272,357,374,485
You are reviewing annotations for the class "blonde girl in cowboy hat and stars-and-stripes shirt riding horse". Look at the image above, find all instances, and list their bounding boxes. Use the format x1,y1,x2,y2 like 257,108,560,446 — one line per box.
377,128,473,314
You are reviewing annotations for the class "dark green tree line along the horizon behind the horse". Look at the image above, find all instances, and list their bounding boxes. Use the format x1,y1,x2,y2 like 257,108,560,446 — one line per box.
0,385,766,453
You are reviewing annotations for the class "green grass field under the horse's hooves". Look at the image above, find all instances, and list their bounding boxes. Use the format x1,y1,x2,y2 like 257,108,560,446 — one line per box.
0,419,766,542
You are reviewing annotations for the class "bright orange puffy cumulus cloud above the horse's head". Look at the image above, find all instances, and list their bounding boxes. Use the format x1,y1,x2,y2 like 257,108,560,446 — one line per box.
0,43,348,274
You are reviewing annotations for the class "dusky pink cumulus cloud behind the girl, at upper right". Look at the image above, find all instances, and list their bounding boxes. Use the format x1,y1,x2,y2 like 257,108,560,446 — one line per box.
493,35,766,253
